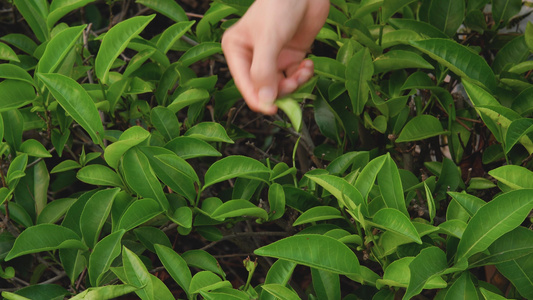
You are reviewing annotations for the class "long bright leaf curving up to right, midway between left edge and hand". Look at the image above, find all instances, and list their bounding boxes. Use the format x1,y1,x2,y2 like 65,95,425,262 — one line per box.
94,15,155,84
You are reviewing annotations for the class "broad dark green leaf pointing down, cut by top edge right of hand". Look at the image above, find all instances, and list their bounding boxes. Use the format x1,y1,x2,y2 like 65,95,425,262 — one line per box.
429,0,465,37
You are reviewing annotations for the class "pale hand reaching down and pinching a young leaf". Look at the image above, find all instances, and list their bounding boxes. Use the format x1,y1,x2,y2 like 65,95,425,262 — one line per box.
222,0,329,115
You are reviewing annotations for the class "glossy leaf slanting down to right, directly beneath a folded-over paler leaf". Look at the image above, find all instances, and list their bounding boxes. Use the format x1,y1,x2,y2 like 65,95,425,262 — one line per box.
122,148,168,209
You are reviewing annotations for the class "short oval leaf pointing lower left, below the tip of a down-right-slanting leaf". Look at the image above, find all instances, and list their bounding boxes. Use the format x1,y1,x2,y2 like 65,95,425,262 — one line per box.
116,198,163,231
